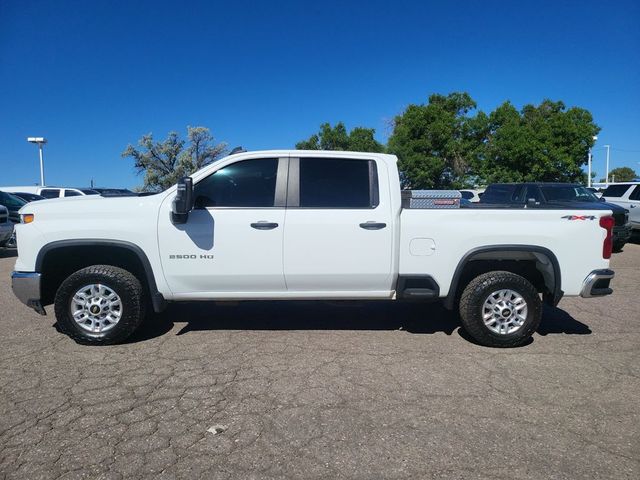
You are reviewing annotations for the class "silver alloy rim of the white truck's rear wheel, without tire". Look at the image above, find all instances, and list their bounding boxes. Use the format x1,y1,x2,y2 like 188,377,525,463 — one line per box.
482,289,527,335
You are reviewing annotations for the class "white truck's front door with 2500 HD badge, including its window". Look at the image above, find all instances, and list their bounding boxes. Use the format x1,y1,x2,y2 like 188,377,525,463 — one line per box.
158,158,288,298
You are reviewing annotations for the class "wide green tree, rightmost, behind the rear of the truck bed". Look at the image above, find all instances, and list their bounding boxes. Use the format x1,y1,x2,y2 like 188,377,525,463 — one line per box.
474,100,600,183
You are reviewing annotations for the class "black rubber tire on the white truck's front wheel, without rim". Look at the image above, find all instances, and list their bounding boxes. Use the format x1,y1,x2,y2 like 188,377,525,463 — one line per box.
55,265,146,345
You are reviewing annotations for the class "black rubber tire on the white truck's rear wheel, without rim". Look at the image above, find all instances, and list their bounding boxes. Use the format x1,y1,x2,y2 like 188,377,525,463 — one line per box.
459,271,542,348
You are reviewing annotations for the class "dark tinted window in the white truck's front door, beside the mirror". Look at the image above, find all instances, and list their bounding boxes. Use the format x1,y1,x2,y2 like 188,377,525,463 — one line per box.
194,158,278,208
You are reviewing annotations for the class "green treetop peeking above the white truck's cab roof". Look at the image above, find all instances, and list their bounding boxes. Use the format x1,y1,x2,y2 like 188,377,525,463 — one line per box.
296,122,384,152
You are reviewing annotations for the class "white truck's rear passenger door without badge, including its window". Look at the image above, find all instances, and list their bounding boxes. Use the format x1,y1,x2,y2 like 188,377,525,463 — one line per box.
284,158,394,297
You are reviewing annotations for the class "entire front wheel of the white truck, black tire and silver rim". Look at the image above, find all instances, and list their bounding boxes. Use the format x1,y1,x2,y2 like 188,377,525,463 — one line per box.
55,265,145,345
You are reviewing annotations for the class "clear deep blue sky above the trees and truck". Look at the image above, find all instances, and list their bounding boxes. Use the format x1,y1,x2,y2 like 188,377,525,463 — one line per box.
0,0,640,187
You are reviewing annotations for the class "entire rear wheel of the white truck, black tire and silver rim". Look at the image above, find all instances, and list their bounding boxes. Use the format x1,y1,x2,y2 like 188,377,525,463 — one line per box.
460,271,542,347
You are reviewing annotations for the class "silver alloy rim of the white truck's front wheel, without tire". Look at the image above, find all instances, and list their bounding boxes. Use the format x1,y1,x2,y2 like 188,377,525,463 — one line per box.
69,283,122,333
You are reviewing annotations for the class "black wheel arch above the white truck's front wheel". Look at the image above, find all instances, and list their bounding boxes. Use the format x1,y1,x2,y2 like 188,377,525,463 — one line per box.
35,239,166,312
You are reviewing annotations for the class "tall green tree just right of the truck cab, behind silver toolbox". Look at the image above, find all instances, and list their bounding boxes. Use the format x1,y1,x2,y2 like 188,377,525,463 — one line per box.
387,92,487,189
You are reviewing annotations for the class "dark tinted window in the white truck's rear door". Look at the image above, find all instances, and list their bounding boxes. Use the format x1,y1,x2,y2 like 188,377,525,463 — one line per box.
300,158,379,208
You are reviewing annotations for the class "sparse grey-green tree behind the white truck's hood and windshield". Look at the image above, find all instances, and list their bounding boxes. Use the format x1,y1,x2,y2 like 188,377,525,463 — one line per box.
122,127,227,192
